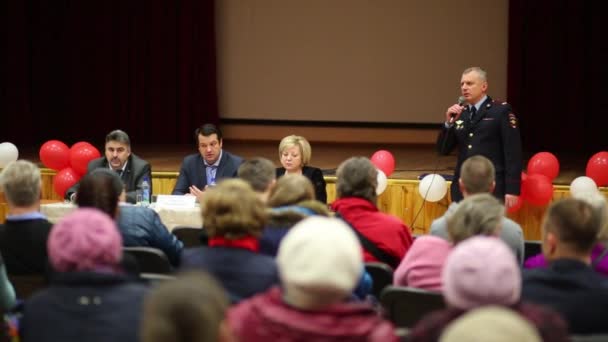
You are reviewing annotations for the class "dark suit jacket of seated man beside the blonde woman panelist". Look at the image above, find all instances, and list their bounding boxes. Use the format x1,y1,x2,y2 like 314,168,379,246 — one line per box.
171,150,243,195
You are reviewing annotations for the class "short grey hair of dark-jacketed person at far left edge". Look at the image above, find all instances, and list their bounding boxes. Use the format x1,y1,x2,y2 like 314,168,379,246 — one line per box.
0,160,42,207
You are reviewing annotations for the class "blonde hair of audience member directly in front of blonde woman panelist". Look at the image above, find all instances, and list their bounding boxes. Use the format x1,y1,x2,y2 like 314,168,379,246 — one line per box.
268,174,315,207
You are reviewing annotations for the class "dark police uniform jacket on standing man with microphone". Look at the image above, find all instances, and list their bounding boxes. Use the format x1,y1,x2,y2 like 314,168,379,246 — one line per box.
437,96,522,202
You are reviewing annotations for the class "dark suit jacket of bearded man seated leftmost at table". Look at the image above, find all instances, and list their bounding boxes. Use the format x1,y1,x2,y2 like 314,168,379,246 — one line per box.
65,153,152,203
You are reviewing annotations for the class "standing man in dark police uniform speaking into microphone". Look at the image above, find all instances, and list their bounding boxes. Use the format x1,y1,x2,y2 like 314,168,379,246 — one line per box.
437,67,522,208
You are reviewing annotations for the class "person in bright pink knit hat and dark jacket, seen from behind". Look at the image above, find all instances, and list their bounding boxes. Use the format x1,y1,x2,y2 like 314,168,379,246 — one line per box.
20,208,147,342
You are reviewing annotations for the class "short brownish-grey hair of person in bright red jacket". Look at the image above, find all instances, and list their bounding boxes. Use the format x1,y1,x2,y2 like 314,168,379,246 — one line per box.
336,157,378,204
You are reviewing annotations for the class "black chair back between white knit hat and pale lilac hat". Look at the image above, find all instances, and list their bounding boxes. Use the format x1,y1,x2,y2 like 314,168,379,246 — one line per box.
380,286,445,328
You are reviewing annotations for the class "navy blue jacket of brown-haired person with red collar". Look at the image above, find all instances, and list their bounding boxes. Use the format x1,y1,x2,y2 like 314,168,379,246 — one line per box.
181,247,279,303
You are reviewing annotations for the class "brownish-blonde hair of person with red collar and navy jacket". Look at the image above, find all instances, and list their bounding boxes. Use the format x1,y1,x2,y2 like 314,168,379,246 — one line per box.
201,179,267,239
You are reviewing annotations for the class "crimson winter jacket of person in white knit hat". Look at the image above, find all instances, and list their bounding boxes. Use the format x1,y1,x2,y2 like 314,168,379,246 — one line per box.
228,287,398,342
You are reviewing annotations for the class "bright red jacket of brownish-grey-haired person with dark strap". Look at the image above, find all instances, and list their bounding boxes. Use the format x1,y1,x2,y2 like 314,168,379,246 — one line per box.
331,197,413,267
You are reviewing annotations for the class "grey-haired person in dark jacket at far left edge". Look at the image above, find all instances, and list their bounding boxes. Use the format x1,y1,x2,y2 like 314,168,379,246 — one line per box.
0,160,52,275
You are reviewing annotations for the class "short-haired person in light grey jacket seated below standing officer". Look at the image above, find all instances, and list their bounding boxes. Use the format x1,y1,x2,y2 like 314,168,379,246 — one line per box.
430,155,524,265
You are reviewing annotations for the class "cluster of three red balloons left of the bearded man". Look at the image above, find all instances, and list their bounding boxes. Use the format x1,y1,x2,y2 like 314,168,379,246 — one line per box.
40,140,101,197
